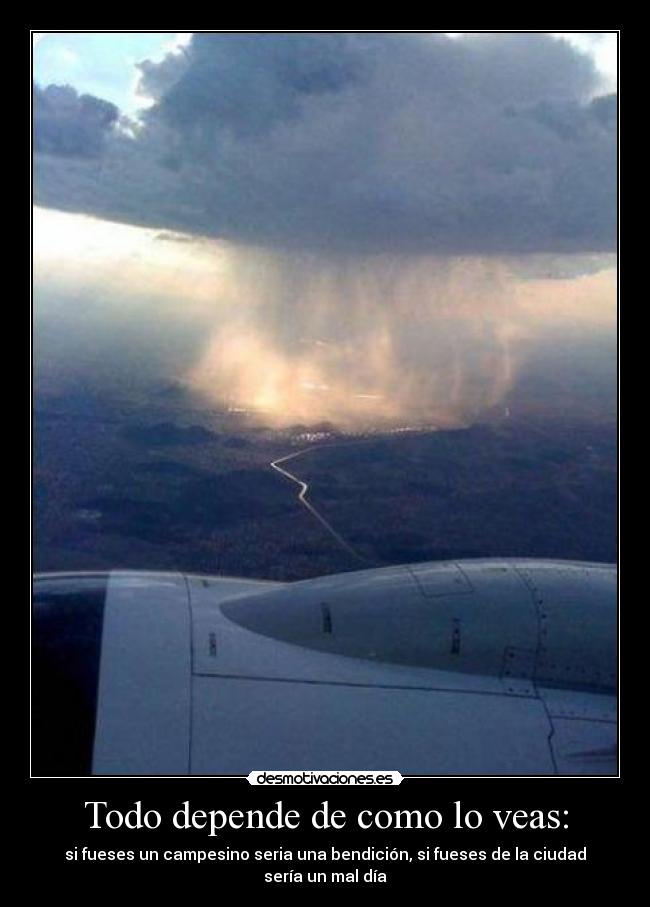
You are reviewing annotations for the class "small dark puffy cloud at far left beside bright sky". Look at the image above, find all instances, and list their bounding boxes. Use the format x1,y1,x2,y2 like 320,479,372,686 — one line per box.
34,85,118,157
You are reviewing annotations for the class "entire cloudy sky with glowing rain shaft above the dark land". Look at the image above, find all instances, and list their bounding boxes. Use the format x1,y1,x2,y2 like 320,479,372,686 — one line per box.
34,32,616,426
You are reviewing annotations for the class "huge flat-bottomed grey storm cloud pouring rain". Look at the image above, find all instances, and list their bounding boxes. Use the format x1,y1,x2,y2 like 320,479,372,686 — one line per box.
36,33,616,253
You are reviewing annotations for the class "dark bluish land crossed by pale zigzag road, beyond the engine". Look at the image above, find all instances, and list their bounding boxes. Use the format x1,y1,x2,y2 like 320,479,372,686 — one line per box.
34,340,617,580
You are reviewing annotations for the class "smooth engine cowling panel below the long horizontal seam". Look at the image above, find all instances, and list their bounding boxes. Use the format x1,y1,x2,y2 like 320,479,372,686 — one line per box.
191,677,554,775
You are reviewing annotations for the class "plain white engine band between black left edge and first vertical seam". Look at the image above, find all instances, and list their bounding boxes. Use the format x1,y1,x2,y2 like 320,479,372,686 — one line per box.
93,573,191,775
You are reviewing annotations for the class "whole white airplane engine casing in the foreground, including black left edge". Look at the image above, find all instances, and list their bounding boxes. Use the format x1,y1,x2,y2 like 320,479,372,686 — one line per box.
32,560,617,775
